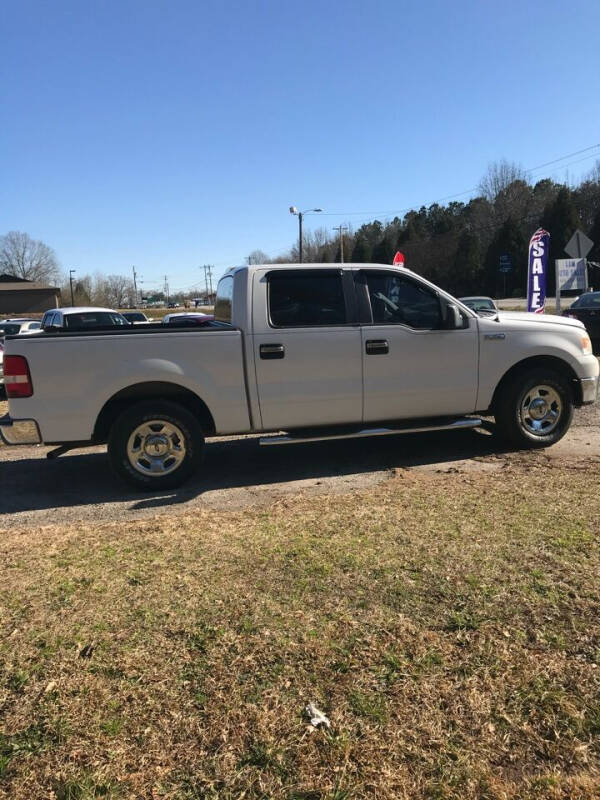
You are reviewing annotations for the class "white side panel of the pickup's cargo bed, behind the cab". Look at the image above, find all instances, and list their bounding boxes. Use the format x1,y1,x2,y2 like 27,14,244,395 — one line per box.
5,322,251,443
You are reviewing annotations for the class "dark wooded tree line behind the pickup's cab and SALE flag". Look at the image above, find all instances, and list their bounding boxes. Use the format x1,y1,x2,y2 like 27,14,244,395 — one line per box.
249,161,600,297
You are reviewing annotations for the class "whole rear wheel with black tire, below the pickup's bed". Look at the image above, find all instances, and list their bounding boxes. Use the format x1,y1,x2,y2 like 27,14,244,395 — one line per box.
108,400,204,492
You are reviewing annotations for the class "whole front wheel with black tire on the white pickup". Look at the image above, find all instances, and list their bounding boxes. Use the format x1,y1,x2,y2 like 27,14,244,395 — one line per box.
494,369,573,448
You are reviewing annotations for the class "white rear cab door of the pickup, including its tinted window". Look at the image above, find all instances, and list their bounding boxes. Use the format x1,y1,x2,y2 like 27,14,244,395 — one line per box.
252,267,362,430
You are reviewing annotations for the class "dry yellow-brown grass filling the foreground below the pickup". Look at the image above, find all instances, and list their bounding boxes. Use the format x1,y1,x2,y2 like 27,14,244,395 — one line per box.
0,455,600,800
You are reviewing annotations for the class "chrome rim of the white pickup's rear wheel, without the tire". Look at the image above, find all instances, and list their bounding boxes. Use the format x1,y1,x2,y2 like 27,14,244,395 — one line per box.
127,419,186,477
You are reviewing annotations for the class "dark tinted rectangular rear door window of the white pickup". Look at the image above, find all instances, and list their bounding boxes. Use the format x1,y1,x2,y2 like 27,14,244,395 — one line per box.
268,270,346,328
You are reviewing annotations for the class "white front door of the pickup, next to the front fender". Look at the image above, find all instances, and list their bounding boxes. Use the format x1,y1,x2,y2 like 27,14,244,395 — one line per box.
356,269,478,423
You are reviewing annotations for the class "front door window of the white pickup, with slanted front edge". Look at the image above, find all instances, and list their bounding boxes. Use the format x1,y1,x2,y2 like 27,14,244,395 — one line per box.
363,270,443,330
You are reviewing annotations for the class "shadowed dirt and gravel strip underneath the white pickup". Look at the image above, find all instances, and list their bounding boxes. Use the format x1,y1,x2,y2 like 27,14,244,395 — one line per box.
0,402,600,526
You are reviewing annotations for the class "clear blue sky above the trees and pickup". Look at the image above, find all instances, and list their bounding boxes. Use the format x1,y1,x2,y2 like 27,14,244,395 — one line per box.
0,0,600,289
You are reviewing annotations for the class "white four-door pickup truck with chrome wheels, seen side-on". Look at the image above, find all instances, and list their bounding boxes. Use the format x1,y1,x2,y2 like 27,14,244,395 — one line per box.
0,264,600,490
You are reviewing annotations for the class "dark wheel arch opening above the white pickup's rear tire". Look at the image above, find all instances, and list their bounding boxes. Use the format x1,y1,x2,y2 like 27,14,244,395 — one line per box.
93,381,216,444
